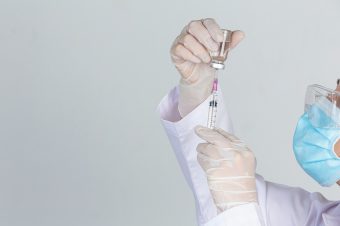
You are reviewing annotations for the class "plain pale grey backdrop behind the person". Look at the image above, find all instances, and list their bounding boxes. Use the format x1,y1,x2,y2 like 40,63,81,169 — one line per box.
0,0,340,226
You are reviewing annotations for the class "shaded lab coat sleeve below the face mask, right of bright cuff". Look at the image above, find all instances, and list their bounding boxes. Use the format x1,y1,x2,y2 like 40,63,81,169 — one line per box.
263,178,340,226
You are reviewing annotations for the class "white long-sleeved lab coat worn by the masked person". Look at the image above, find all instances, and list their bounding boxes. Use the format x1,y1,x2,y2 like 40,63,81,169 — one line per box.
158,87,340,226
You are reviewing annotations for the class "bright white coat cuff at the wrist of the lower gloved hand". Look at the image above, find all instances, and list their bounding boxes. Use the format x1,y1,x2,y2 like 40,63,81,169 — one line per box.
203,203,265,226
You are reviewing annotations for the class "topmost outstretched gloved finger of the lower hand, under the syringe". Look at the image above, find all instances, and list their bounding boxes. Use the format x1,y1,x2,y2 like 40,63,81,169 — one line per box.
195,126,230,148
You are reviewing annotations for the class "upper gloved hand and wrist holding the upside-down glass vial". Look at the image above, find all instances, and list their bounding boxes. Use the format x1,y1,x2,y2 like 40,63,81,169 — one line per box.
170,18,244,117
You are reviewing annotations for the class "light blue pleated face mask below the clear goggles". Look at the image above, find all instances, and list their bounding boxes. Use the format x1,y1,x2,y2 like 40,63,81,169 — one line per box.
293,105,340,186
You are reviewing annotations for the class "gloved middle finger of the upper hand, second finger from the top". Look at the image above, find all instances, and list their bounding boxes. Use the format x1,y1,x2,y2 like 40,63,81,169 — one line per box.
187,20,218,51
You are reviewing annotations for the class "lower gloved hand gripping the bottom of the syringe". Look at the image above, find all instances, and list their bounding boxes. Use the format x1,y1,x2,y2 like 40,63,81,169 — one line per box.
195,126,257,212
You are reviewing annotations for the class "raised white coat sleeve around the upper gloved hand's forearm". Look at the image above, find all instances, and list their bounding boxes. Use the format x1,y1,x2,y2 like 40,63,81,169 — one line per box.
158,87,232,225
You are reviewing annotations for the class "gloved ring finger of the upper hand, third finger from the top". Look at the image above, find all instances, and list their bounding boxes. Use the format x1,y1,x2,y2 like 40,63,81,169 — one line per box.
178,34,211,63
